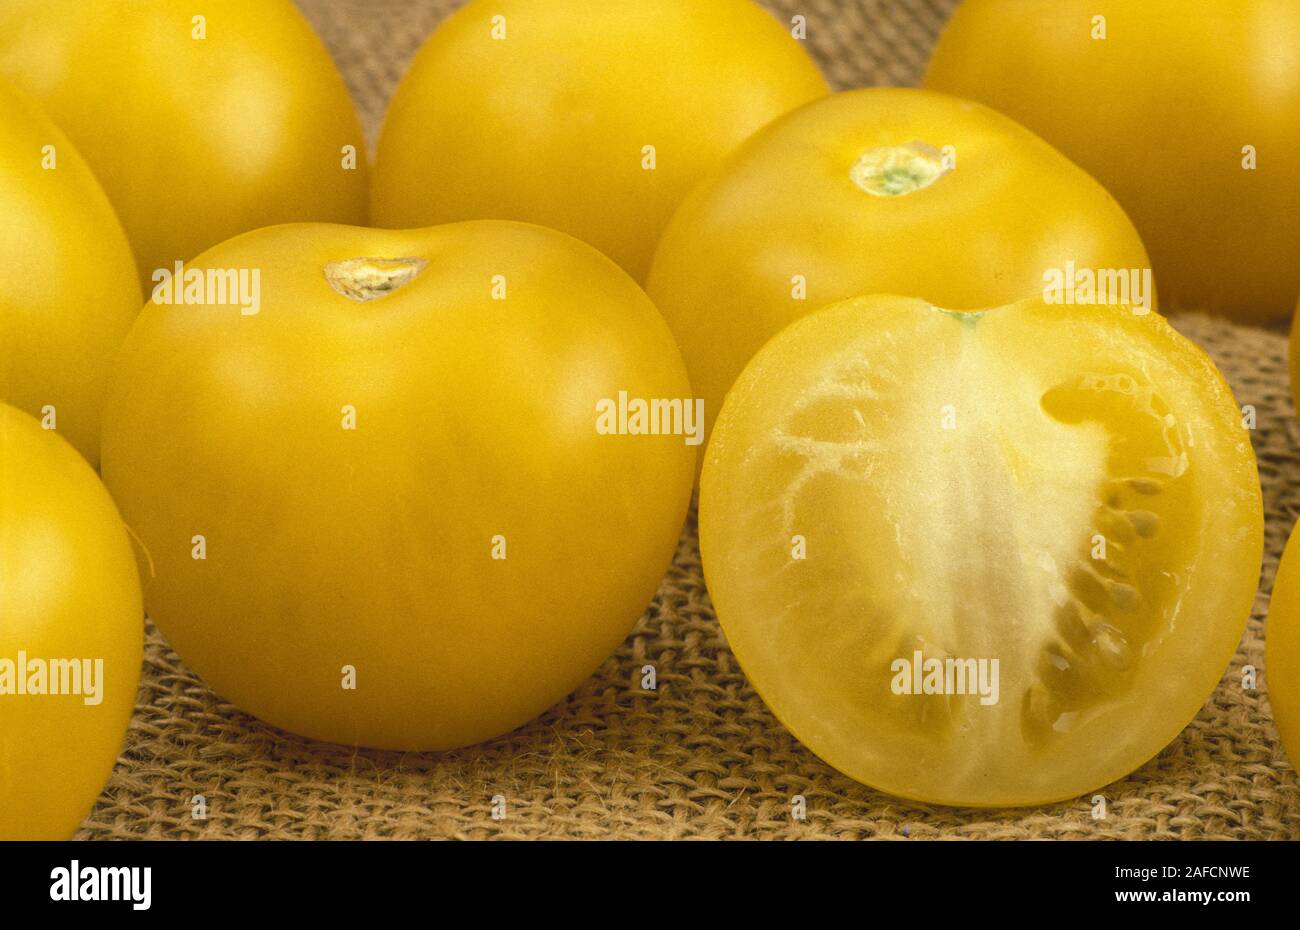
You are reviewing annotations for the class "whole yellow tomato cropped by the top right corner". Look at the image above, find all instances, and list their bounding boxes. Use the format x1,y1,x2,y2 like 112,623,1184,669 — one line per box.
926,0,1300,321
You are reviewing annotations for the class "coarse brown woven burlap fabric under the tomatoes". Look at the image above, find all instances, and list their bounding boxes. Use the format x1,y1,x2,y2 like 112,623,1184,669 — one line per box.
79,0,1300,839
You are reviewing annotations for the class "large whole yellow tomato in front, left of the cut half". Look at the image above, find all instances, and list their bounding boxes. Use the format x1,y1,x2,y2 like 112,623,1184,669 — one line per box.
104,221,701,749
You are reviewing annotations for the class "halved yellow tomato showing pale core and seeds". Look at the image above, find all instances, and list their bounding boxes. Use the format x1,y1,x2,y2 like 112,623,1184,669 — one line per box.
699,297,1264,806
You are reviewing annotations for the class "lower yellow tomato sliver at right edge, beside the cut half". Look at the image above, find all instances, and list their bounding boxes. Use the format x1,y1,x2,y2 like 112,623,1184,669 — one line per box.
1264,520,1300,769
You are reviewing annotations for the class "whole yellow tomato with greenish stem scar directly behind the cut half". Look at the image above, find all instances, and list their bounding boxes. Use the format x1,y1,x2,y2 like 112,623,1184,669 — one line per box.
646,87,1154,455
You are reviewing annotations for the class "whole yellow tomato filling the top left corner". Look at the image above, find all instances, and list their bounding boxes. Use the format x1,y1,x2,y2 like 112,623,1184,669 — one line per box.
0,0,368,291
